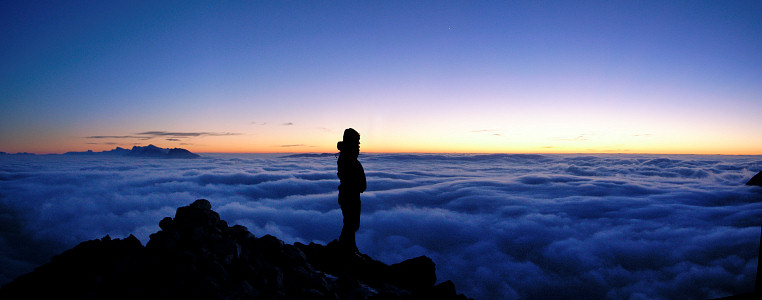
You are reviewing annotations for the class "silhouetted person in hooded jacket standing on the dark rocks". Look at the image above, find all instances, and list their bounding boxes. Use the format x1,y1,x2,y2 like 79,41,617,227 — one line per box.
336,128,367,252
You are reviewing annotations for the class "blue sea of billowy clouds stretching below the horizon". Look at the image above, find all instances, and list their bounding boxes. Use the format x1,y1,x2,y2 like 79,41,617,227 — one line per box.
0,154,762,299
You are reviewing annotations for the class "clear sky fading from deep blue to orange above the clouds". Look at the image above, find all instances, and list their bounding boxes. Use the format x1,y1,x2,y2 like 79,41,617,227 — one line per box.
0,1,762,154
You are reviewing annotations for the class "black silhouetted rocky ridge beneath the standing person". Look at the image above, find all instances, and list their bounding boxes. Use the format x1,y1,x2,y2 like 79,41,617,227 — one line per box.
0,199,467,299
